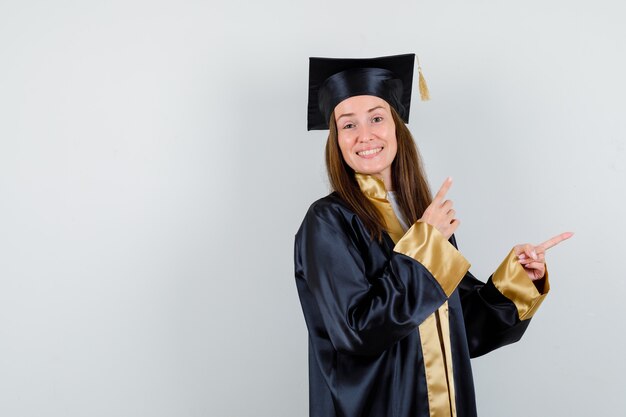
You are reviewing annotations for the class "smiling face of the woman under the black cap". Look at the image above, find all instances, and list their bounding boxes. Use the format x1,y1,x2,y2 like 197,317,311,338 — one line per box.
335,96,398,186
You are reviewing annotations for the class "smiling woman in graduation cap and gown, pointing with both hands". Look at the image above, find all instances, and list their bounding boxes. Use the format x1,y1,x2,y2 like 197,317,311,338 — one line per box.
295,54,572,417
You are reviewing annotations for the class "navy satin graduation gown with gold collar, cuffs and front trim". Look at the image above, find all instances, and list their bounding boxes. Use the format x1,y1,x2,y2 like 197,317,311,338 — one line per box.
295,174,549,417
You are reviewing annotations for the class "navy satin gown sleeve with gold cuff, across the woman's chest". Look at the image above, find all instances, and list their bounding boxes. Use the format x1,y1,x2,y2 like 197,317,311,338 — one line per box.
295,201,469,355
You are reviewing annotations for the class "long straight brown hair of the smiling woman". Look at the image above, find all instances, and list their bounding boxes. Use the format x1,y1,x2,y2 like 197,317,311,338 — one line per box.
326,106,432,241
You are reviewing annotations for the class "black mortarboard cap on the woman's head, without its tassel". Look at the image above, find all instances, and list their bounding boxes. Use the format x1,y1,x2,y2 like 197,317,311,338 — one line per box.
307,54,415,130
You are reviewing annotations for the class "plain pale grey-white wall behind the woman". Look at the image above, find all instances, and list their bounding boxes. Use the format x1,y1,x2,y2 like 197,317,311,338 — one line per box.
0,0,626,417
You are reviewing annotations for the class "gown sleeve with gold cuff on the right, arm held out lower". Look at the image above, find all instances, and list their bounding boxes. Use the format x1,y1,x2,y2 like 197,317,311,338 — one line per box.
451,236,550,357
